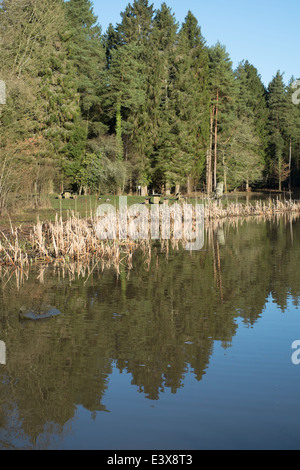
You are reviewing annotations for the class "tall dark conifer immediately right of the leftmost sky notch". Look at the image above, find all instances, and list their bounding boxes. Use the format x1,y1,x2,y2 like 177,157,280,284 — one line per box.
109,0,154,193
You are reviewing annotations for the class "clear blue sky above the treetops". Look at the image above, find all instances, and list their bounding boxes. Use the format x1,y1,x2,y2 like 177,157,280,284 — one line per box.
92,0,300,86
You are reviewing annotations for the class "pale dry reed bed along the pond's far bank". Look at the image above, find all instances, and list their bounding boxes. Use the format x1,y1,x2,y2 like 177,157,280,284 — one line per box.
0,196,300,270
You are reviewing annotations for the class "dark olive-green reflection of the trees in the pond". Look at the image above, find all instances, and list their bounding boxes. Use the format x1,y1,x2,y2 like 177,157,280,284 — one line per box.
0,214,300,448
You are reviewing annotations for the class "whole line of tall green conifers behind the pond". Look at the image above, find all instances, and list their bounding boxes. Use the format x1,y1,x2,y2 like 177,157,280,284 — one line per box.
0,0,300,210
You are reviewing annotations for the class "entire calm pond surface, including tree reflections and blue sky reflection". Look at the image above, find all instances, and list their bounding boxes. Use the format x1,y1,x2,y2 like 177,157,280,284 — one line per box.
0,217,300,450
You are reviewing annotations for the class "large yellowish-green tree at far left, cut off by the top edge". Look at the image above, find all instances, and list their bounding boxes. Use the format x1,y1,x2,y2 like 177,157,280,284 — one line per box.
0,0,78,203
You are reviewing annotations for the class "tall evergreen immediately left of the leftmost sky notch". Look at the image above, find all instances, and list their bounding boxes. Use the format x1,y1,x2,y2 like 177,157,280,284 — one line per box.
65,0,107,192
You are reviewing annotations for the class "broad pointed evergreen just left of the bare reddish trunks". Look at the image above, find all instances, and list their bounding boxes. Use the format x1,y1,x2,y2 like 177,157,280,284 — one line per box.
156,12,209,193
